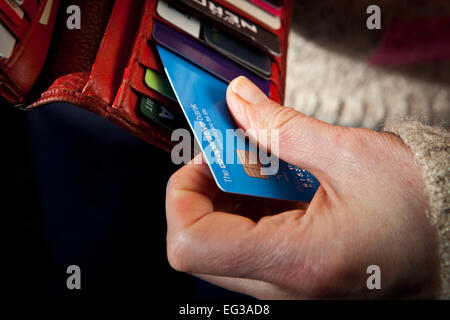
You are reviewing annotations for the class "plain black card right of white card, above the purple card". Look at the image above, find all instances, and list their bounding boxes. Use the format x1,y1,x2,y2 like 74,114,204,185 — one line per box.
203,24,272,80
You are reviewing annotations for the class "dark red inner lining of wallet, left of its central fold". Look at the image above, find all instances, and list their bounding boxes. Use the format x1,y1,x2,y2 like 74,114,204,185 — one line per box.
30,0,114,107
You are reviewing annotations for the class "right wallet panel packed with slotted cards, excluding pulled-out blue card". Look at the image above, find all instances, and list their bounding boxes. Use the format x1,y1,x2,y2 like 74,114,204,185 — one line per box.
137,0,283,133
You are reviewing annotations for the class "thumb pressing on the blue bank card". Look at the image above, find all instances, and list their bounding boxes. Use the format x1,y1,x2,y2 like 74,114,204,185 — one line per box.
227,77,341,184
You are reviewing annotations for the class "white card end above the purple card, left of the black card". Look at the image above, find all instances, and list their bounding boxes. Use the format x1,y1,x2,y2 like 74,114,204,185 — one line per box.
156,0,202,39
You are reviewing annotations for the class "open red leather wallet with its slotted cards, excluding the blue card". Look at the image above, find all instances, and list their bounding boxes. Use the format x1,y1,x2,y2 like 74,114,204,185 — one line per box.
0,0,292,151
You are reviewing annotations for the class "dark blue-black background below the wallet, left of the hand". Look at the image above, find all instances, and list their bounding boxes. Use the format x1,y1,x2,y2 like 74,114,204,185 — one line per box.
0,103,251,301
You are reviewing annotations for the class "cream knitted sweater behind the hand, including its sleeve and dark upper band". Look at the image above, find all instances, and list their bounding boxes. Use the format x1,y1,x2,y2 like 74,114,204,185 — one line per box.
286,0,450,299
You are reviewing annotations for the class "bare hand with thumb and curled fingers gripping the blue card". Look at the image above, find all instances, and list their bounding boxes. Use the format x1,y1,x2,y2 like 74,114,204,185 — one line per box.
166,77,439,299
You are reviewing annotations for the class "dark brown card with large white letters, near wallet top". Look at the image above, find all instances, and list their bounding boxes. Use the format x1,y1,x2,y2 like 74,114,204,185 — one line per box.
167,0,281,56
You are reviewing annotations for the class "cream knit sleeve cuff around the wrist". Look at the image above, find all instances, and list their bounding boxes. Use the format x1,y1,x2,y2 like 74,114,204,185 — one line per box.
385,121,450,299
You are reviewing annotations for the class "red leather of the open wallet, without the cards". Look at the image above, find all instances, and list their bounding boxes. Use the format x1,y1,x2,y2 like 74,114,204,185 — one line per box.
0,0,292,151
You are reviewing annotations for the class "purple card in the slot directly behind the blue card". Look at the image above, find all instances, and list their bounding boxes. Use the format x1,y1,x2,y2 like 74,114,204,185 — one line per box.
153,21,270,95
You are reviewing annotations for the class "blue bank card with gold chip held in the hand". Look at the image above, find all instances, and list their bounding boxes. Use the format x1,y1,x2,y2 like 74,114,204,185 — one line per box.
157,45,319,202
